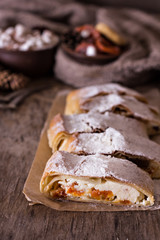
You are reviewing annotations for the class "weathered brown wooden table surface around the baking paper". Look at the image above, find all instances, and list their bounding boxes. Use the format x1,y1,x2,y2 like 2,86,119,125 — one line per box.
0,80,160,240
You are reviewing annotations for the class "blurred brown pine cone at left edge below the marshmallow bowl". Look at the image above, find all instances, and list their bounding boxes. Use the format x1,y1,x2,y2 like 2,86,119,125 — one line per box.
0,70,29,90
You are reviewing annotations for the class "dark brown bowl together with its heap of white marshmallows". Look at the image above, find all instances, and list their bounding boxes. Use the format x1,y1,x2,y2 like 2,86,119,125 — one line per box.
0,24,59,76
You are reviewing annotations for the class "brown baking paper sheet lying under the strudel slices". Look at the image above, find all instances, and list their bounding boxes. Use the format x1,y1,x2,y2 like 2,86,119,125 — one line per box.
23,89,160,212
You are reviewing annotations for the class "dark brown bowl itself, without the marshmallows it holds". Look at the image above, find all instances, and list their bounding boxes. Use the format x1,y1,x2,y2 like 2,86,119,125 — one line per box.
0,36,59,76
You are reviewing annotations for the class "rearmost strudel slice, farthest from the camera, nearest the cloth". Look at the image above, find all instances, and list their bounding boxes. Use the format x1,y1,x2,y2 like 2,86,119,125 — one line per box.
65,83,147,114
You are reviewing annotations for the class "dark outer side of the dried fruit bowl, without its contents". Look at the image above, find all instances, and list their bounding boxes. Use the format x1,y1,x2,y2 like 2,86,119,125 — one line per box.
61,43,119,65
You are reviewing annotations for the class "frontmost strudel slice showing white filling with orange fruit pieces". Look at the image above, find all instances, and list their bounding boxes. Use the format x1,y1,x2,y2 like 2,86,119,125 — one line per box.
40,152,154,206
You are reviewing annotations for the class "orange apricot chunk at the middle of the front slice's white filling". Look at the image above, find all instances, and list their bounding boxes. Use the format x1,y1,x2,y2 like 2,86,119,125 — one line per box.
91,188,114,201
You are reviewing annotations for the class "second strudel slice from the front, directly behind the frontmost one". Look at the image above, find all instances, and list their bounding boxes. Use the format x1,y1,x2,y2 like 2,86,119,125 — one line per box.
56,127,160,178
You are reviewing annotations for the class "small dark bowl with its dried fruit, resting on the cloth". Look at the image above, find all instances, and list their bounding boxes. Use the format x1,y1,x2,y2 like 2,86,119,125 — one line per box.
61,23,128,65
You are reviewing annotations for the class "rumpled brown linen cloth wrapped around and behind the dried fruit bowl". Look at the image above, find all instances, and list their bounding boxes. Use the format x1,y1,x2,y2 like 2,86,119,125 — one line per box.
0,0,160,87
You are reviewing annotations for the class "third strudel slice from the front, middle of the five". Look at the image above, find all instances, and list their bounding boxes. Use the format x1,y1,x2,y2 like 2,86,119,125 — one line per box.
48,112,148,152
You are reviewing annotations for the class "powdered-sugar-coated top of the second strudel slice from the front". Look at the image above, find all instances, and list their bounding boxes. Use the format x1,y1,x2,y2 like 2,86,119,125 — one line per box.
71,128,160,164
